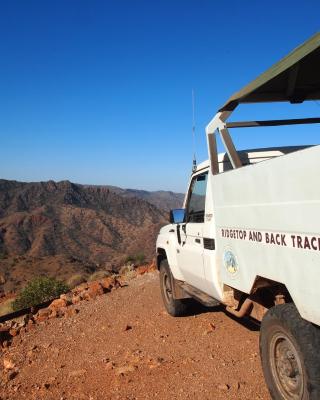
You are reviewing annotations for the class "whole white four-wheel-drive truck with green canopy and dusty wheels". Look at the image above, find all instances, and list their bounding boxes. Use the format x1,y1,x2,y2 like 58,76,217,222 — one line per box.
157,33,320,400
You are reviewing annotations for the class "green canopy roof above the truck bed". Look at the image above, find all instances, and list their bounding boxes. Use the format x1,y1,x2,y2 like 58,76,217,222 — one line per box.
219,33,320,111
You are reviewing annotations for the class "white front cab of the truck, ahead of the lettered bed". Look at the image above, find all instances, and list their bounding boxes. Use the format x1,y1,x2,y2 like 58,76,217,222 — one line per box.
157,146,310,302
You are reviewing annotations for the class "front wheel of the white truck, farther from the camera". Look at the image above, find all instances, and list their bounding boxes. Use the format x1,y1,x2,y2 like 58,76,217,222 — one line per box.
160,260,189,317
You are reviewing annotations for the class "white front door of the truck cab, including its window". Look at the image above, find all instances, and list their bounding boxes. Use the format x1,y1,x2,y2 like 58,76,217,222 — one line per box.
177,172,208,290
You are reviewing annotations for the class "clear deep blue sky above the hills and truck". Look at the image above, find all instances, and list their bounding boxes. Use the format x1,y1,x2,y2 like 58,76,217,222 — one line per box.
0,0,320,191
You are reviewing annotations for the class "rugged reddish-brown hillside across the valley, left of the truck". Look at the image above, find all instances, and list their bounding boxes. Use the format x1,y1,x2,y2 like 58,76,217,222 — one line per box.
0,180,167,291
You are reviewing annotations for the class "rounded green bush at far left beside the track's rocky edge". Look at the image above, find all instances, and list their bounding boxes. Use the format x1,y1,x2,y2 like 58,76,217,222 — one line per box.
12,277,69,311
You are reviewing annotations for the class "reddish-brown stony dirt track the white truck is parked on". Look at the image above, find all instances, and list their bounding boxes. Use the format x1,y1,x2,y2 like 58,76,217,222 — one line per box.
0,273,270,400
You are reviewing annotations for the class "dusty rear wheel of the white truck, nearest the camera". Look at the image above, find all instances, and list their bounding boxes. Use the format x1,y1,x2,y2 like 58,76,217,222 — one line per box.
260,304,320,400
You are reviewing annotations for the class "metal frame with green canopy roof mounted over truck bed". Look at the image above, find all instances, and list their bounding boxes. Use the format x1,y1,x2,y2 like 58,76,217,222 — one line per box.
206,33,320,174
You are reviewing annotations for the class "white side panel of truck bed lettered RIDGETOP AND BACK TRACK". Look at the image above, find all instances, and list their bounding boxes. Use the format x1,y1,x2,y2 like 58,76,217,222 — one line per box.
211,146,320,324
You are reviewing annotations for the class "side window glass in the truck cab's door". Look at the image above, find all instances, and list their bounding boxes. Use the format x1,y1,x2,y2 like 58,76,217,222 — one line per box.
187,172,208,222
